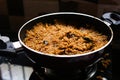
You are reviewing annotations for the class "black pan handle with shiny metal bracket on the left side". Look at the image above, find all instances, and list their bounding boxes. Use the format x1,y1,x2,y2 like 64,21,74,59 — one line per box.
0,39,23,57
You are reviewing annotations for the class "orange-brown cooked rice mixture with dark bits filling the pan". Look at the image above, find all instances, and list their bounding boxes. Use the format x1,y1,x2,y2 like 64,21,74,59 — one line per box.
24,23,108,55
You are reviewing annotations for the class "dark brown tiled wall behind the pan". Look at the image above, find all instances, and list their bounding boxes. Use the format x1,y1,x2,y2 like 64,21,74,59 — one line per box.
0,0,120,32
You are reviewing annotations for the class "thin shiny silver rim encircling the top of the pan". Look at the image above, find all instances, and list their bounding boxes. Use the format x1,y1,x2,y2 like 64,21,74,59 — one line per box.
18,12,113,58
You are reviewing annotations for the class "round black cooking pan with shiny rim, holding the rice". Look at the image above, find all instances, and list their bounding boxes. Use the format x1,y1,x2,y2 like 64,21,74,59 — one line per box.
0,12,113,69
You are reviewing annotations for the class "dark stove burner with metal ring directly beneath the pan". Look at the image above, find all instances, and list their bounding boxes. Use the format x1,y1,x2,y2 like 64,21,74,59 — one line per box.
29,64,97,80
